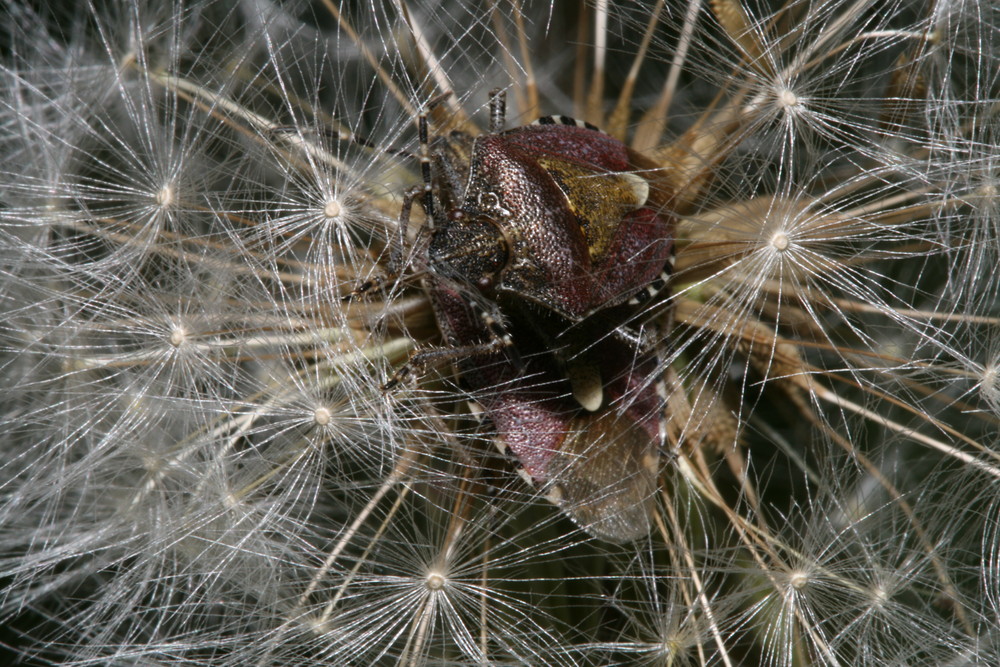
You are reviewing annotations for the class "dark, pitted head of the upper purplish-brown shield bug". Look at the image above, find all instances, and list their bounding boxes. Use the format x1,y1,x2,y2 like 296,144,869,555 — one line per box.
429,209,510,289
